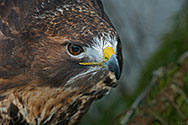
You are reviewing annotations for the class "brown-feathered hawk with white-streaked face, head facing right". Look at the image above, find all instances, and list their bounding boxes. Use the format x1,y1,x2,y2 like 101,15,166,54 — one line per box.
0,0,122,125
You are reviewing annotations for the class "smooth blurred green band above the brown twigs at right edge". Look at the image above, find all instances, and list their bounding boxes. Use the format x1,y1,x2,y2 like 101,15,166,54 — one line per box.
139,2,188,94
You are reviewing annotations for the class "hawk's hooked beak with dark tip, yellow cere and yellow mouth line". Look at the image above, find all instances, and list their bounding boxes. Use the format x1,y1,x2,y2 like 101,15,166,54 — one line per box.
79,47,121,80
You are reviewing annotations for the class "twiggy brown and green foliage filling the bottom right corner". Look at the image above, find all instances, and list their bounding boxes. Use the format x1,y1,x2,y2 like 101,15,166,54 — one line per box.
128,57,188,125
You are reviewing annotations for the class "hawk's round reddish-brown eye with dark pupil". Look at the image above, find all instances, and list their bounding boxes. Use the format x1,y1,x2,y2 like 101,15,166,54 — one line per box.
68,44,84,56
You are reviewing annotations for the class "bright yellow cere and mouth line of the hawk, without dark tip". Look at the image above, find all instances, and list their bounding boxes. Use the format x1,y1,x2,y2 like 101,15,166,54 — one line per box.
79,47,115,66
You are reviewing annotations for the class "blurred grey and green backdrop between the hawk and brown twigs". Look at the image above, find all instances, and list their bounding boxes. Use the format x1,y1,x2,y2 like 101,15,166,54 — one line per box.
82,0,188,125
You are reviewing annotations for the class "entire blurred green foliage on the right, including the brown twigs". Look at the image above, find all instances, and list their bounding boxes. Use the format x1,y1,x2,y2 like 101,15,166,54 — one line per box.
123,2,188,125
